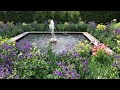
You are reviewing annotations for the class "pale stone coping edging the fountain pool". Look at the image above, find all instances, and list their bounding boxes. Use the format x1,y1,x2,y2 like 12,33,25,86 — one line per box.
11,31,113,54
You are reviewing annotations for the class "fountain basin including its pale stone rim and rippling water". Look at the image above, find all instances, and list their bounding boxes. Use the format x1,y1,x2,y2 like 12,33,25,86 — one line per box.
12,31,112,53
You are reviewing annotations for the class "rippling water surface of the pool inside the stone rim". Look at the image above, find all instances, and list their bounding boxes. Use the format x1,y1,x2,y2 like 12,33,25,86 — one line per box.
17,33,89,54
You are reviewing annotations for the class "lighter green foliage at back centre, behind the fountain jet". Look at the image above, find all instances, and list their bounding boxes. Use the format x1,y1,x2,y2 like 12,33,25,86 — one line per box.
34,11,80,23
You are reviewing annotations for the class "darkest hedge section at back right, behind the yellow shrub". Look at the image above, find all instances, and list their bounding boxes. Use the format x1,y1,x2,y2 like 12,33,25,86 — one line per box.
80,11,120,23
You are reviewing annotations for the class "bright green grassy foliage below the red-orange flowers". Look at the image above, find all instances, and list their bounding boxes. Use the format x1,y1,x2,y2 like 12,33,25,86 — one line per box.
87,58,119,79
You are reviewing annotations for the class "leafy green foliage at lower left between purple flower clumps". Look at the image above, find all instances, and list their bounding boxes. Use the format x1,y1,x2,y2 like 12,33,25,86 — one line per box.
13,57,49,79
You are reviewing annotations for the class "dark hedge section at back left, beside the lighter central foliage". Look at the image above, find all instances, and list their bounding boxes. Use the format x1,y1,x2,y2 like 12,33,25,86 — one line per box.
0,11,35,23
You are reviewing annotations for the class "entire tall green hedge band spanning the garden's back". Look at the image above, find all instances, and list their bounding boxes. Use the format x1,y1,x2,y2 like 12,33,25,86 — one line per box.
0,11,120,23
